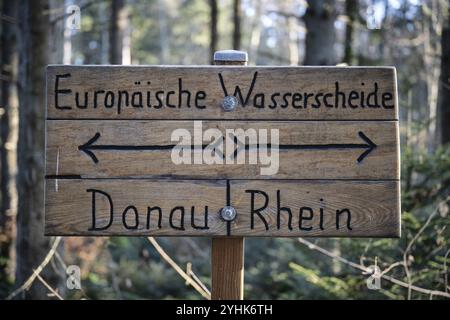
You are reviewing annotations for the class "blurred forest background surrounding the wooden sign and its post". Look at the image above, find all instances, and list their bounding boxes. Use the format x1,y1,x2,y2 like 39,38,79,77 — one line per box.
0,0,450,299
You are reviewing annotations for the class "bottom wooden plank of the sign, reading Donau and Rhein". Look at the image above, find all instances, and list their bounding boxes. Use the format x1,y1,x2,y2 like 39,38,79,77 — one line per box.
45,179,400,237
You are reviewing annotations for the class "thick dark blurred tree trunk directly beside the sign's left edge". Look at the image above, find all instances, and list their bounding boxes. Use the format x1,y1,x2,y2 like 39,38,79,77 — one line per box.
16,0,61,299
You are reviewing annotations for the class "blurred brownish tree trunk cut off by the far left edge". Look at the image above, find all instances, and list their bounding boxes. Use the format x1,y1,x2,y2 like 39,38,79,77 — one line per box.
0,0,17,284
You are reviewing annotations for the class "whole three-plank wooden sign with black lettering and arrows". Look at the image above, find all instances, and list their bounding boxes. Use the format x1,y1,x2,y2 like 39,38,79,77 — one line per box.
45,66,400,237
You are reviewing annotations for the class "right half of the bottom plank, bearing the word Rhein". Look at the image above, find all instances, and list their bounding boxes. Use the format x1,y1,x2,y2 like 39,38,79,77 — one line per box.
230,180,401,237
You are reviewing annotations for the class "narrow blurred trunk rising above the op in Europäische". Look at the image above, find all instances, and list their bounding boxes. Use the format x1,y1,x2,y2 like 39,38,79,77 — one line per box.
109,0,128,64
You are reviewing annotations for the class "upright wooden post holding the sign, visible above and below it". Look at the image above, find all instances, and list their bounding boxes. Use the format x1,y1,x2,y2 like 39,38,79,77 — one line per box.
211,50,247,300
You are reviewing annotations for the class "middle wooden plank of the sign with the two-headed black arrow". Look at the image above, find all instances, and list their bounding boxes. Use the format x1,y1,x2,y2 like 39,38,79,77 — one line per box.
46,120,399,179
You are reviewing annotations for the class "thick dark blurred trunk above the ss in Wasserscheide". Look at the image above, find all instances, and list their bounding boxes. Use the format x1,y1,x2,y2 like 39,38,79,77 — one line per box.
303,0,336,65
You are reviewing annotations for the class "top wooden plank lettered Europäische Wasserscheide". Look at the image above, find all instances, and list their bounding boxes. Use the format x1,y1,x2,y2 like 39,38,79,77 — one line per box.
47,66,398,120
